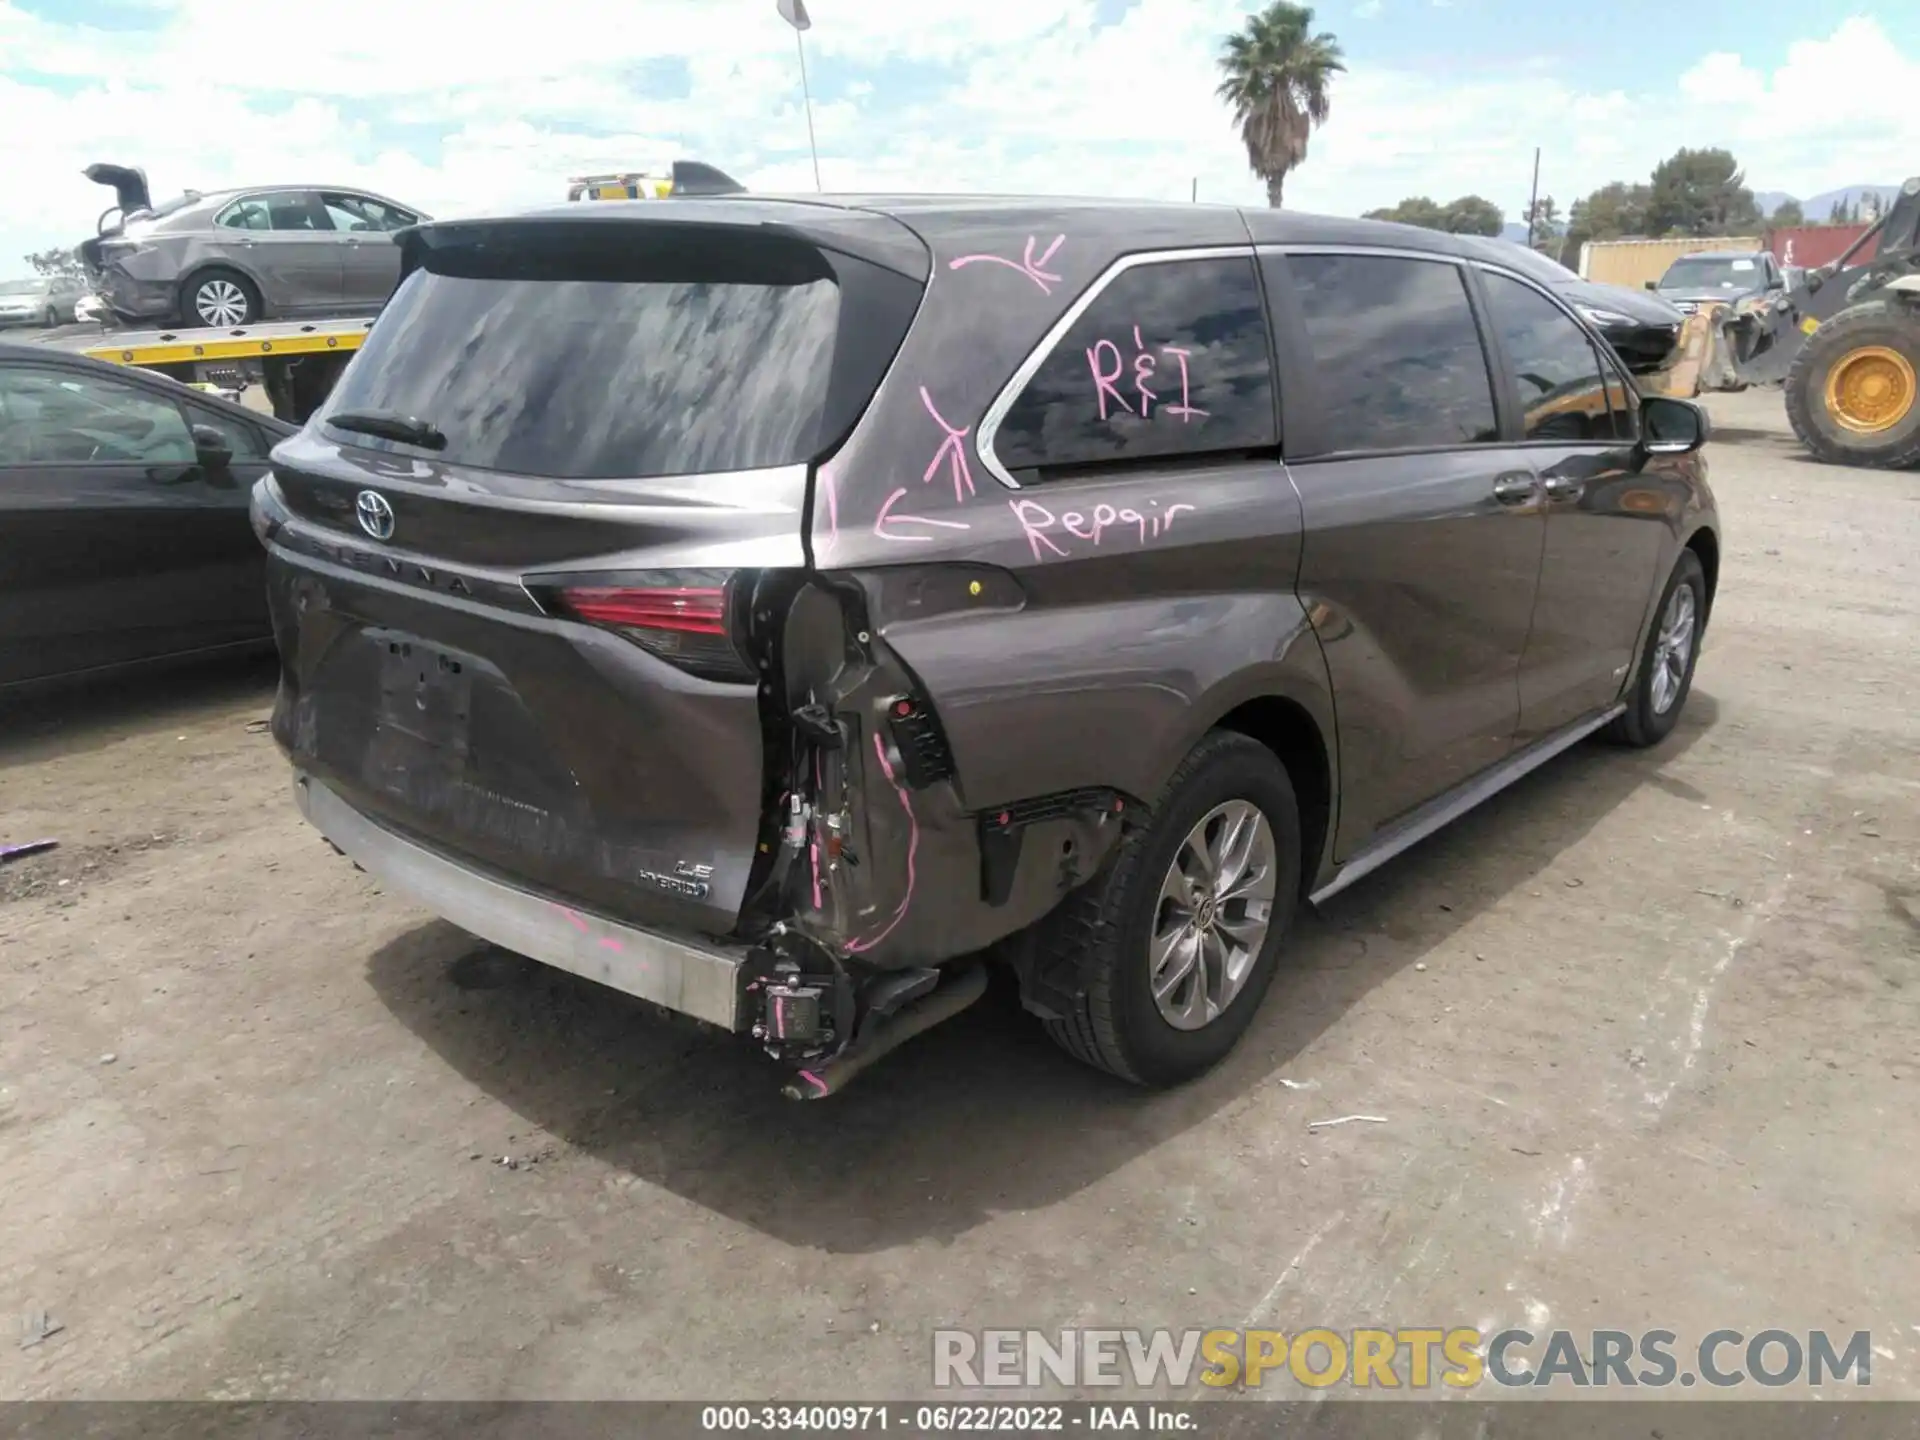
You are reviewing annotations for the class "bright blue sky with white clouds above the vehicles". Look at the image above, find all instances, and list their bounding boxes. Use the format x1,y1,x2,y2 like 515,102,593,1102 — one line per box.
0,0,1920,269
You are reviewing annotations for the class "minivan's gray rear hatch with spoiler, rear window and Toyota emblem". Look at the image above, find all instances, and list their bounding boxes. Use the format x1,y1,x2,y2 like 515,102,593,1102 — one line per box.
255,200,927,935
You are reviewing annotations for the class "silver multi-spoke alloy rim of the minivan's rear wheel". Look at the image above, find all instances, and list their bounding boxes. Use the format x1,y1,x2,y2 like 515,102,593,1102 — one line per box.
1148,801,1279,1029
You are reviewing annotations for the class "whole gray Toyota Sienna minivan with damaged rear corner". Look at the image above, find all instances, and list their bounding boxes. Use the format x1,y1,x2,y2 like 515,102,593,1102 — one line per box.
253,196,1720,1096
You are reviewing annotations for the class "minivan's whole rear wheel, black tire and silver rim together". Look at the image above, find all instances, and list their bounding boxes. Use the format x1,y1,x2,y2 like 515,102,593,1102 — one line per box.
1041,732,1300,1085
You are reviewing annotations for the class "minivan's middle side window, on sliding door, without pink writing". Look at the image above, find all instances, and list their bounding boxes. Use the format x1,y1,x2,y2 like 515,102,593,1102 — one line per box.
1286,255,1500,453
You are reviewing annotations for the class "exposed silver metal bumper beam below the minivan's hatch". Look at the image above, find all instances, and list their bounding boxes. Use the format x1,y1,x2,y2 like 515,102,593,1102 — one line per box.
294,776,747,1031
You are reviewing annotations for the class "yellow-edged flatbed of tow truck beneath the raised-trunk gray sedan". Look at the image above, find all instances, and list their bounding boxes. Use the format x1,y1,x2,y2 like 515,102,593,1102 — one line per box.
36,315,372,424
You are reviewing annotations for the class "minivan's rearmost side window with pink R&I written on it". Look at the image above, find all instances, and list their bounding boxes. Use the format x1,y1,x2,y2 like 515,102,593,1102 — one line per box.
993,255,1279,480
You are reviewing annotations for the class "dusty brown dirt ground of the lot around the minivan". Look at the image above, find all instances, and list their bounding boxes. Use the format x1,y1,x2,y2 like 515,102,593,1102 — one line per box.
0,392,1920,1398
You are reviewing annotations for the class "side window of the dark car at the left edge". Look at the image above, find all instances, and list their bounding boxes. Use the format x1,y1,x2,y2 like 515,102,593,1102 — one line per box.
0,365,194,465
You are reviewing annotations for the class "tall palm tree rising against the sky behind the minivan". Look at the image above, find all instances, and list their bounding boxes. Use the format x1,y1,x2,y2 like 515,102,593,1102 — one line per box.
1219,0,1346,209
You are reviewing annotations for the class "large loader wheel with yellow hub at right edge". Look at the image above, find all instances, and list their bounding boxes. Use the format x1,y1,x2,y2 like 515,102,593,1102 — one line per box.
1786,300,1920,468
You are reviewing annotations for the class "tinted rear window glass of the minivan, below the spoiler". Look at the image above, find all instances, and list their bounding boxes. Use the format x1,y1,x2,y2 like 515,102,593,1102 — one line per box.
321,238,839,480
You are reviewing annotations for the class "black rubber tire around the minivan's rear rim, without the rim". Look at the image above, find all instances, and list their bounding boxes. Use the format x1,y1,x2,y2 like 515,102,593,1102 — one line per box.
1035,732,1300,1087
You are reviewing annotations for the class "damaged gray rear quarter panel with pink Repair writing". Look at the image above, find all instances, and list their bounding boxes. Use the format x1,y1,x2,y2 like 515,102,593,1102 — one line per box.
795,205,1332,966
